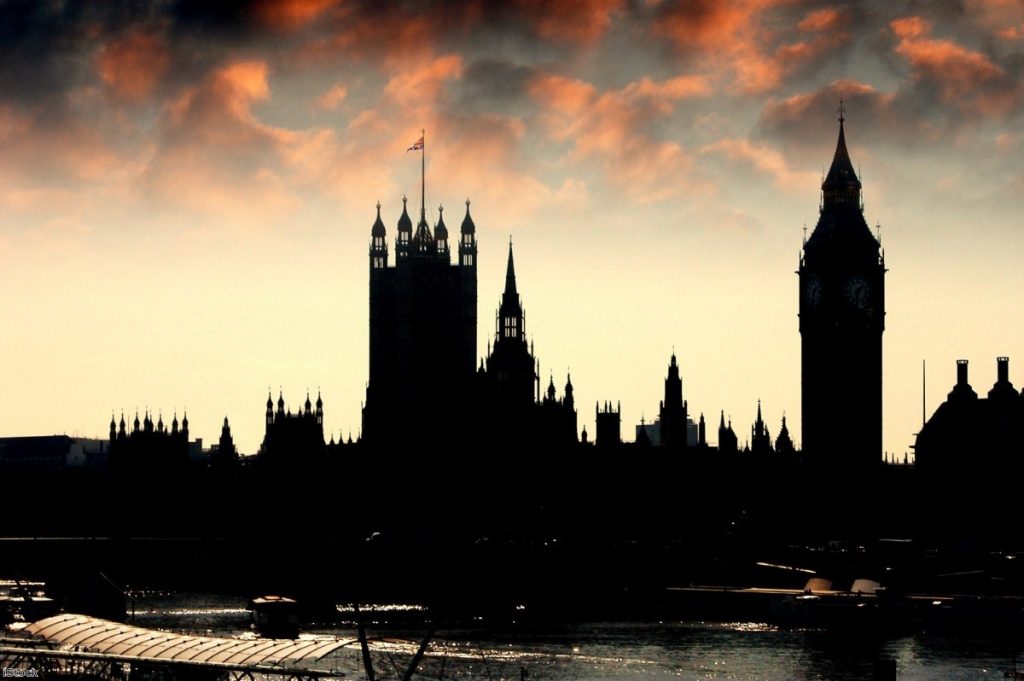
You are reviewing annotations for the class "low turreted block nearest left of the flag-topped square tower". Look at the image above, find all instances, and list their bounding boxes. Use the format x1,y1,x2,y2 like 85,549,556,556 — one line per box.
262,392,327,464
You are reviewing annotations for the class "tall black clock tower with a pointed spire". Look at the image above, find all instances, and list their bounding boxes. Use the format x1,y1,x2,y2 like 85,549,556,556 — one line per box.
797,102,886,474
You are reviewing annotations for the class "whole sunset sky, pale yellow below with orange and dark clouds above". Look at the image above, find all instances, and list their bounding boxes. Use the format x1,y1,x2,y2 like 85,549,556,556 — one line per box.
0,0,1024,457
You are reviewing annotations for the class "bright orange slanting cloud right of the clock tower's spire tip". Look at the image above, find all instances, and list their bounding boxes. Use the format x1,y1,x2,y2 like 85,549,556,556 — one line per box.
889,16,1015,116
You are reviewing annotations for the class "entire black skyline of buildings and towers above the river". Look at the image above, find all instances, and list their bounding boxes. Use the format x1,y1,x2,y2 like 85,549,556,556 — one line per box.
0,111,1024,548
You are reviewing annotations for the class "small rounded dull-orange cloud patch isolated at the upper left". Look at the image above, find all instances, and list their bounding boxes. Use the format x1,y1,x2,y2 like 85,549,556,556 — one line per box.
96,33,170,101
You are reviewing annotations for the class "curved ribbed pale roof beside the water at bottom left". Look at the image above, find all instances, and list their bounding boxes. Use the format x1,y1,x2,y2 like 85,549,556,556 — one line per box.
26,614,358,667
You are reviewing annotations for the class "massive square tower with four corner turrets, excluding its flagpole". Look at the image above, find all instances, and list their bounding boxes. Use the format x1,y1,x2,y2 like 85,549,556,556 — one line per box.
362,193,477,444
